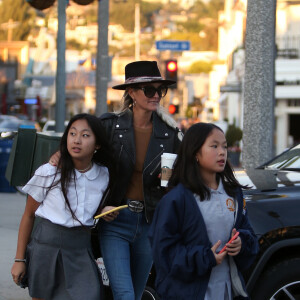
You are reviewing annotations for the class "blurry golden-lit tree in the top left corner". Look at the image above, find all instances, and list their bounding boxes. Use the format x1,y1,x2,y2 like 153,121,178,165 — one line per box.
0,0,36,41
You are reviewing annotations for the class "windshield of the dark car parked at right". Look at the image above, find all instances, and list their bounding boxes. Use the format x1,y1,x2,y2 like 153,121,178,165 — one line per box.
265,144,300,171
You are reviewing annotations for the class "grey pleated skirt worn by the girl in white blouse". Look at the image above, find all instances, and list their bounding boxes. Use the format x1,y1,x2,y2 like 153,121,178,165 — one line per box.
26,219,102,300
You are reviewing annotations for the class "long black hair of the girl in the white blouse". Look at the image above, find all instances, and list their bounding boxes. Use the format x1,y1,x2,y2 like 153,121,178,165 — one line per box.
49,113,116,223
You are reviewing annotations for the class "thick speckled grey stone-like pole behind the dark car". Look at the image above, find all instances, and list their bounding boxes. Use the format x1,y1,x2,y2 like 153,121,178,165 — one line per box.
243,0,276,169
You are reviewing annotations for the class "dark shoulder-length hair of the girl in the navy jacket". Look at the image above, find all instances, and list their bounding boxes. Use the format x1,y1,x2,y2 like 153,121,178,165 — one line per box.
168,123,248,201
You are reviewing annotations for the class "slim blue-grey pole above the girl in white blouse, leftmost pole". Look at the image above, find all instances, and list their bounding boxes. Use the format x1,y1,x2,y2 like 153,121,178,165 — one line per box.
55,0,68,132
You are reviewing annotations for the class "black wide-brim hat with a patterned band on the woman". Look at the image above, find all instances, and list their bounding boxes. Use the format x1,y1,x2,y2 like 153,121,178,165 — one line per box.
112,61,176,90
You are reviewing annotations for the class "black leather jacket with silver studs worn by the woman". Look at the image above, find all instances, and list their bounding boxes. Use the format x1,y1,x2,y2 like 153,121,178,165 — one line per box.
100,109,182,222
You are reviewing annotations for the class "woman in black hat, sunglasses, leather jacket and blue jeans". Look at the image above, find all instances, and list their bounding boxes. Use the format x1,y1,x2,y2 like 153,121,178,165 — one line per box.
99,61,182,300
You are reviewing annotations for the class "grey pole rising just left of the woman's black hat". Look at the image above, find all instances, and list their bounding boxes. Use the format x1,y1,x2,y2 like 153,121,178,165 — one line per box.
95,0,109,116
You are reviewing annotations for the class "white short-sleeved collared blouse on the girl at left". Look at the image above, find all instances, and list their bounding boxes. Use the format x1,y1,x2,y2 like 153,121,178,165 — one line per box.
23,163,109,227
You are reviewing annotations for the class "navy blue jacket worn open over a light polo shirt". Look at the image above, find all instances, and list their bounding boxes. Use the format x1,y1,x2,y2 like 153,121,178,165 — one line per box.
149,184,258,300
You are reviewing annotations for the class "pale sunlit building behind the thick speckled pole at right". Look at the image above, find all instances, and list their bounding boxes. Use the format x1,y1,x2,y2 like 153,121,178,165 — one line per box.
218,0,300,154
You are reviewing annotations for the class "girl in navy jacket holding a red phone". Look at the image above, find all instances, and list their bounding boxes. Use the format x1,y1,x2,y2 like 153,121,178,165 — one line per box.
149,123,258,300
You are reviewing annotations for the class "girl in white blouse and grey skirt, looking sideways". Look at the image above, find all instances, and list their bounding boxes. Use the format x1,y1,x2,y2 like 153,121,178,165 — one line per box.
11,114,114,300
